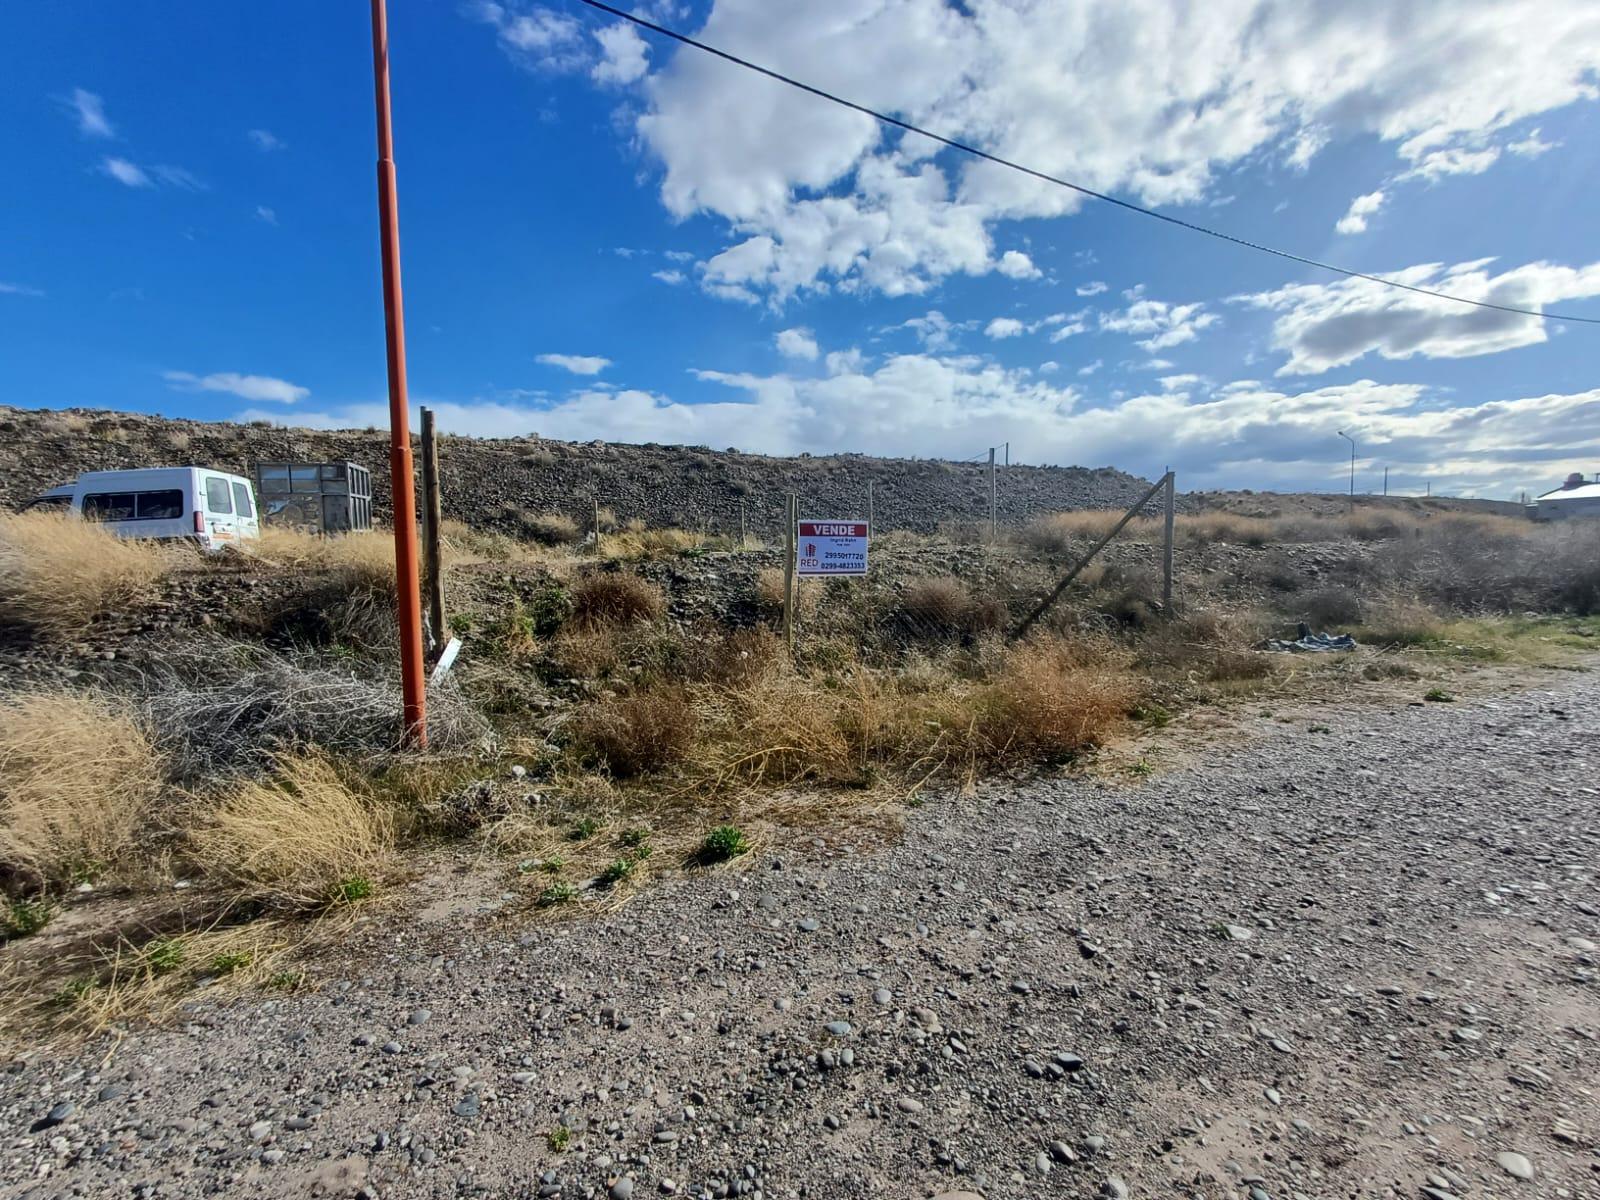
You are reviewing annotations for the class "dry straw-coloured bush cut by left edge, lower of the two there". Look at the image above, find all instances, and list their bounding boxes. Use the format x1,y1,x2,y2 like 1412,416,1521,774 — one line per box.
0,691,163,891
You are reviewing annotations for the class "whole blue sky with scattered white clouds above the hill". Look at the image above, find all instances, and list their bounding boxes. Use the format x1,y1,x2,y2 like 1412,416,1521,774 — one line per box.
0,0,1600,496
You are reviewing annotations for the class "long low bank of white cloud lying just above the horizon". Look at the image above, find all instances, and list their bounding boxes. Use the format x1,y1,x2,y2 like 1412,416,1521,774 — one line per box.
238,354,1600,494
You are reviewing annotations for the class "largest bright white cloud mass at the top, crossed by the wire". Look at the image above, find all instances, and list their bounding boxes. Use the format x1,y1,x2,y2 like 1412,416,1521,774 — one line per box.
556,0,1600,304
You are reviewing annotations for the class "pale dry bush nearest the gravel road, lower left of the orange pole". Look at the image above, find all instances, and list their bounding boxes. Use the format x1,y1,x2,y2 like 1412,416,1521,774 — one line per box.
190,752,394,909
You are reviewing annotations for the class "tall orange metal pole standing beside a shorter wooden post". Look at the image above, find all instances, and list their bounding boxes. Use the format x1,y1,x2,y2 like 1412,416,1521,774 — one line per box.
373,0,427,747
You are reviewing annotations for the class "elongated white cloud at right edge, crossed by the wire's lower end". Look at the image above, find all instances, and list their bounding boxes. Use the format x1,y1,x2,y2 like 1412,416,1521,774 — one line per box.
1234,259,1600,374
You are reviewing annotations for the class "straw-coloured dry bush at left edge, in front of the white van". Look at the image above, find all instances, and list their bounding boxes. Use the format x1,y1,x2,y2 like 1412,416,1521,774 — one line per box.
0,512,170,637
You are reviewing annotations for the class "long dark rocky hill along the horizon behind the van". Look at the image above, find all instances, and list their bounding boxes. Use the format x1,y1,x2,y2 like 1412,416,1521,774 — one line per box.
0,406,1177,536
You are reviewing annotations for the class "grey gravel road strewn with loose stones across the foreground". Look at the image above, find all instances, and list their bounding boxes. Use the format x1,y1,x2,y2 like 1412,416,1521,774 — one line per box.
0,674,1600,1200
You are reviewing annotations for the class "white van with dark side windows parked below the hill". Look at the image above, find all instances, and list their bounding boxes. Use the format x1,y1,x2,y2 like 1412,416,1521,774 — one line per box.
27,467,261,550
